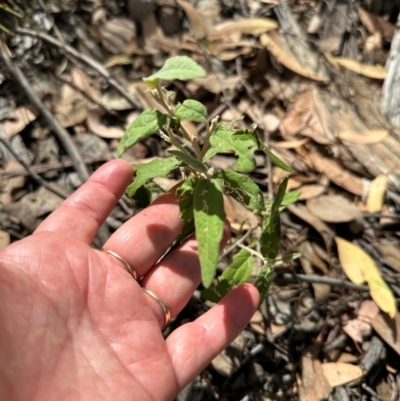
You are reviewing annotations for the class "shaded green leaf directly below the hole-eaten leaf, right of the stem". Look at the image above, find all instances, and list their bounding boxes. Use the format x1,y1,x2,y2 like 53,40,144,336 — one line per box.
213,170,265,211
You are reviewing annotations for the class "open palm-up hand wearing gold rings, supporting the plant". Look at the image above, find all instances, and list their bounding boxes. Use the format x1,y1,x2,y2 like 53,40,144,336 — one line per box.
0,160,259,401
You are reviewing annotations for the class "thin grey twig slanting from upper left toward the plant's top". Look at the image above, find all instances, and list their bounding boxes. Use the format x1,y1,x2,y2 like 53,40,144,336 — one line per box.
16,28,143,111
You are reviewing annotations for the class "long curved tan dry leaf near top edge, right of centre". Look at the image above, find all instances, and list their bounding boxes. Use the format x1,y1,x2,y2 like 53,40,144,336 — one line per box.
207,18,278,41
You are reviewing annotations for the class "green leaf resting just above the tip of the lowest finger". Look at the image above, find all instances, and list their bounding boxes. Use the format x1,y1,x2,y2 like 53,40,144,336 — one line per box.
202,250,254,302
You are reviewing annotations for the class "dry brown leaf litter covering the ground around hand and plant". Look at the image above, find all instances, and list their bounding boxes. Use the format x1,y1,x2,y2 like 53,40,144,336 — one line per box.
0,0,400,401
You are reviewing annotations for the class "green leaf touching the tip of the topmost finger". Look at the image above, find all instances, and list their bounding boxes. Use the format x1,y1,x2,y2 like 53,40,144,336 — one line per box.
126,157,182,197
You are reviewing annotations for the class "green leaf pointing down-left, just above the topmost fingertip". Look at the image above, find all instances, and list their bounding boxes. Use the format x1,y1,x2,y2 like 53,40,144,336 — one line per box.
118,109,167,157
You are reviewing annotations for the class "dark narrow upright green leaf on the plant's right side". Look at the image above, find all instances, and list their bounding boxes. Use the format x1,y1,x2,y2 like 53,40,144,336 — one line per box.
260,177,289,260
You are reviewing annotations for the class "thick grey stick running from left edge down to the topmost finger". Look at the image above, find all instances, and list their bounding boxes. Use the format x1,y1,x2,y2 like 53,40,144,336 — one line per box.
0,43,89,182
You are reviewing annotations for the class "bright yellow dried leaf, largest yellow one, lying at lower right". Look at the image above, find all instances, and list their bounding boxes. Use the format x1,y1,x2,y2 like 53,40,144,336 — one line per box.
335,237,397,318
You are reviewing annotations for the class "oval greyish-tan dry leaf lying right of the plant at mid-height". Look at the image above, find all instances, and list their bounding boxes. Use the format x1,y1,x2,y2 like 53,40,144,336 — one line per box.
306,195,362,223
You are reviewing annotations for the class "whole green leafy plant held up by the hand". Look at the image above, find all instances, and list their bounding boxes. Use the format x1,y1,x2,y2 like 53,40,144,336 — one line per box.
118,57,297,301
